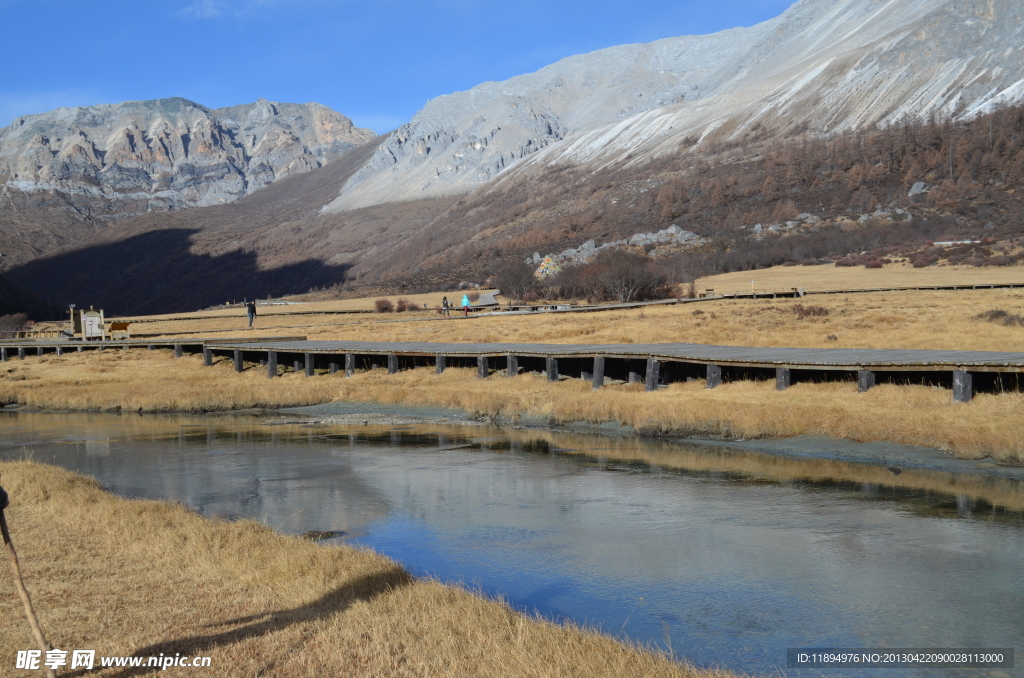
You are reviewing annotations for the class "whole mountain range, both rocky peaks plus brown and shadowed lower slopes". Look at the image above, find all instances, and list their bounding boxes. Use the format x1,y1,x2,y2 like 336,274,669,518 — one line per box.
8,0,1024,319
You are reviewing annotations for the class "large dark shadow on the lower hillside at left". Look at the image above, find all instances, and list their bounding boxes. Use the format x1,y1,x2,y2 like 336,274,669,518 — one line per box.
7,228,348,315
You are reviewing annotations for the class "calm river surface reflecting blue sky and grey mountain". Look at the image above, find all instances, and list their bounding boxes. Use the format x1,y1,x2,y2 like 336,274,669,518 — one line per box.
0,415,1024,676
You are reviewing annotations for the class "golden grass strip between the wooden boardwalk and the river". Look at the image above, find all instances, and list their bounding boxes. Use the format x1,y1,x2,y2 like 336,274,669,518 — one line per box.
0,350,1024,463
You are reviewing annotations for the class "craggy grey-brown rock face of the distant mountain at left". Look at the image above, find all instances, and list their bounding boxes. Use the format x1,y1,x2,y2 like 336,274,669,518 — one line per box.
0,98,375,210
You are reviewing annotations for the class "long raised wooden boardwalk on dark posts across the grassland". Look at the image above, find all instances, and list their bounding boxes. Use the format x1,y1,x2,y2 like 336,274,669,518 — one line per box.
0,337,1024,401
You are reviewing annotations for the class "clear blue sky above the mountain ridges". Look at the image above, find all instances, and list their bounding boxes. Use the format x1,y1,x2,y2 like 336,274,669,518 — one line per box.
0,0,791,132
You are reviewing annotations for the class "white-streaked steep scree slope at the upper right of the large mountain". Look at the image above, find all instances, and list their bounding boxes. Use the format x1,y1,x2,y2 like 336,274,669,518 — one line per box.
516,0,1024,178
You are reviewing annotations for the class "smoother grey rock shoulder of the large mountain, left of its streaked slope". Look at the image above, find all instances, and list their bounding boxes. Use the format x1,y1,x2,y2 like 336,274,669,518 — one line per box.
326,25,767,211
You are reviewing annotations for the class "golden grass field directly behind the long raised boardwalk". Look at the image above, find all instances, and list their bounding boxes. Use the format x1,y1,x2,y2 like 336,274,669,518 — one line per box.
70,290,1024,351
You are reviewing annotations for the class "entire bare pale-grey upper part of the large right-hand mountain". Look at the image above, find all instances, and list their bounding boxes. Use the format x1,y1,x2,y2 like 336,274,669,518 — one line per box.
325,0,1024,211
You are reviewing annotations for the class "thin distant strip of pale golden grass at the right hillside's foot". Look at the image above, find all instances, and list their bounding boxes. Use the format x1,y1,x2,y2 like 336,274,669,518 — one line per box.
696,264,1024,294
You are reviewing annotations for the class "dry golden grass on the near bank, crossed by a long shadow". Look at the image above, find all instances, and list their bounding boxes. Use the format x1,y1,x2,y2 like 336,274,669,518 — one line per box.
0,462,726,678
